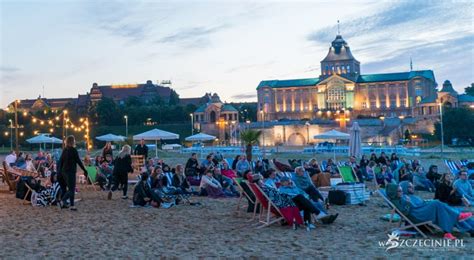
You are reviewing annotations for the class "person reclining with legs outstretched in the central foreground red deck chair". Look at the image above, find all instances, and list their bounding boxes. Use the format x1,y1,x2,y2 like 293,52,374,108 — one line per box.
278,177,337,225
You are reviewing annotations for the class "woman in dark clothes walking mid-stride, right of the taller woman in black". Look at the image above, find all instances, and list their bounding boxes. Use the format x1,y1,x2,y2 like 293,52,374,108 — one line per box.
107,145,133,200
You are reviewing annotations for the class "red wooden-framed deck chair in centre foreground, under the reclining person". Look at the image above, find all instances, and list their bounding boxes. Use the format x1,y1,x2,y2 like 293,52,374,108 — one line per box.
248,183,303,228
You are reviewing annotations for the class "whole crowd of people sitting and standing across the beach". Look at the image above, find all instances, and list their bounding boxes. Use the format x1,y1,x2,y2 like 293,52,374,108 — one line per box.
1,136,474,236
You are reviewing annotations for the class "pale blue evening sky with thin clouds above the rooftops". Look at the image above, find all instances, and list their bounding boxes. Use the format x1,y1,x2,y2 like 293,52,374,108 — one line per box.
0,0,474,107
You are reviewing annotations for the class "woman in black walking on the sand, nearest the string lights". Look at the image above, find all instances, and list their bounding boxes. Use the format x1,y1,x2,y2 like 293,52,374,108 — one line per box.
58,135,87,211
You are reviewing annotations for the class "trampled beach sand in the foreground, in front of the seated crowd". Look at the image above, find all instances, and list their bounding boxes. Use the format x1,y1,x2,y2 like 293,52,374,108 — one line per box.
0,184,474,259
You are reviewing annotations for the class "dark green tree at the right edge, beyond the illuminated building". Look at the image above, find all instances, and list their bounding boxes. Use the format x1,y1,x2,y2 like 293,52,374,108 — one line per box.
435,107,474,146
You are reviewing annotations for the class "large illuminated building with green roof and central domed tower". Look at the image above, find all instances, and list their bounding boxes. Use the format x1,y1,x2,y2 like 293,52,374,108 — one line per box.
257,35,437,121
